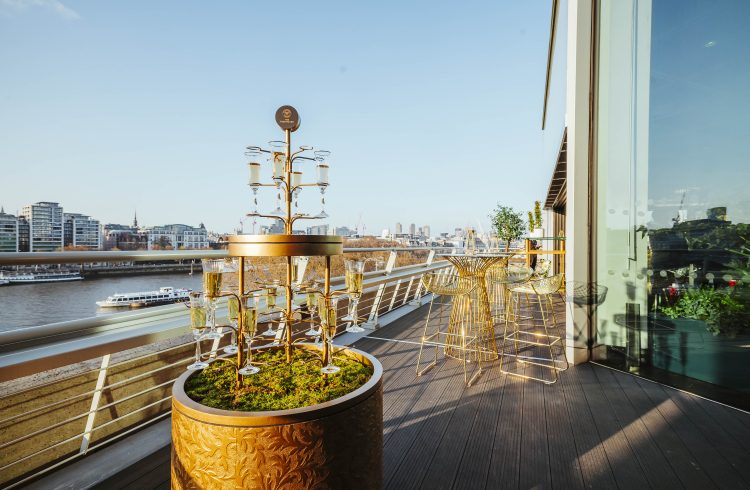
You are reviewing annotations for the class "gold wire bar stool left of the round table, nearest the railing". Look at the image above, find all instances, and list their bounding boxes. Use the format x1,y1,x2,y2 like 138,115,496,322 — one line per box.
417,271,482,386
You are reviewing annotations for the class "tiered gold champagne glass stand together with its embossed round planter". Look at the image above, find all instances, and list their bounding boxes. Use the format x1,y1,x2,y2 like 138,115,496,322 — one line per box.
171,106,383,490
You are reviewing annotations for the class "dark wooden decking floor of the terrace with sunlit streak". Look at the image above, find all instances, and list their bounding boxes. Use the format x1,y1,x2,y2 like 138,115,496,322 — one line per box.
27,300,750,490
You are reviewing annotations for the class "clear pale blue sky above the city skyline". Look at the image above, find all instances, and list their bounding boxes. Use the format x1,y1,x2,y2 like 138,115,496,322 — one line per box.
0,0,554,235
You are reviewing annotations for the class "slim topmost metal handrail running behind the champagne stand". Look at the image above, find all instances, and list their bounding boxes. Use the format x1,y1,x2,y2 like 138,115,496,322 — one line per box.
0,247,453,265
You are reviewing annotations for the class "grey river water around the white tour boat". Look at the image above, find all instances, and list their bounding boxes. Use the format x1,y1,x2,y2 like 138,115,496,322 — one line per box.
0,272,201,330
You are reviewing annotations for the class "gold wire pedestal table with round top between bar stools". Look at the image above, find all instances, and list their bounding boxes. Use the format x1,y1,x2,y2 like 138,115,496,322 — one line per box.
440,254,512,361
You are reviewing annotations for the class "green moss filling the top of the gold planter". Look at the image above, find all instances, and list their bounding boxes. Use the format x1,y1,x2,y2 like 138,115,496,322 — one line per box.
185,349,372,412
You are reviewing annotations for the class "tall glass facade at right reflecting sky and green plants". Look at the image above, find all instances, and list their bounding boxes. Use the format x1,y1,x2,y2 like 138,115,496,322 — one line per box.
592,0,750,409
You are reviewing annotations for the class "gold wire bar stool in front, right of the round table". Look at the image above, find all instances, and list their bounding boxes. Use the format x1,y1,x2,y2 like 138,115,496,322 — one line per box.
500,274,568,384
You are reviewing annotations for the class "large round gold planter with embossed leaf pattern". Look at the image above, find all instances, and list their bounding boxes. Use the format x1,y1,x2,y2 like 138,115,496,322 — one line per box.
172,344,383,490
